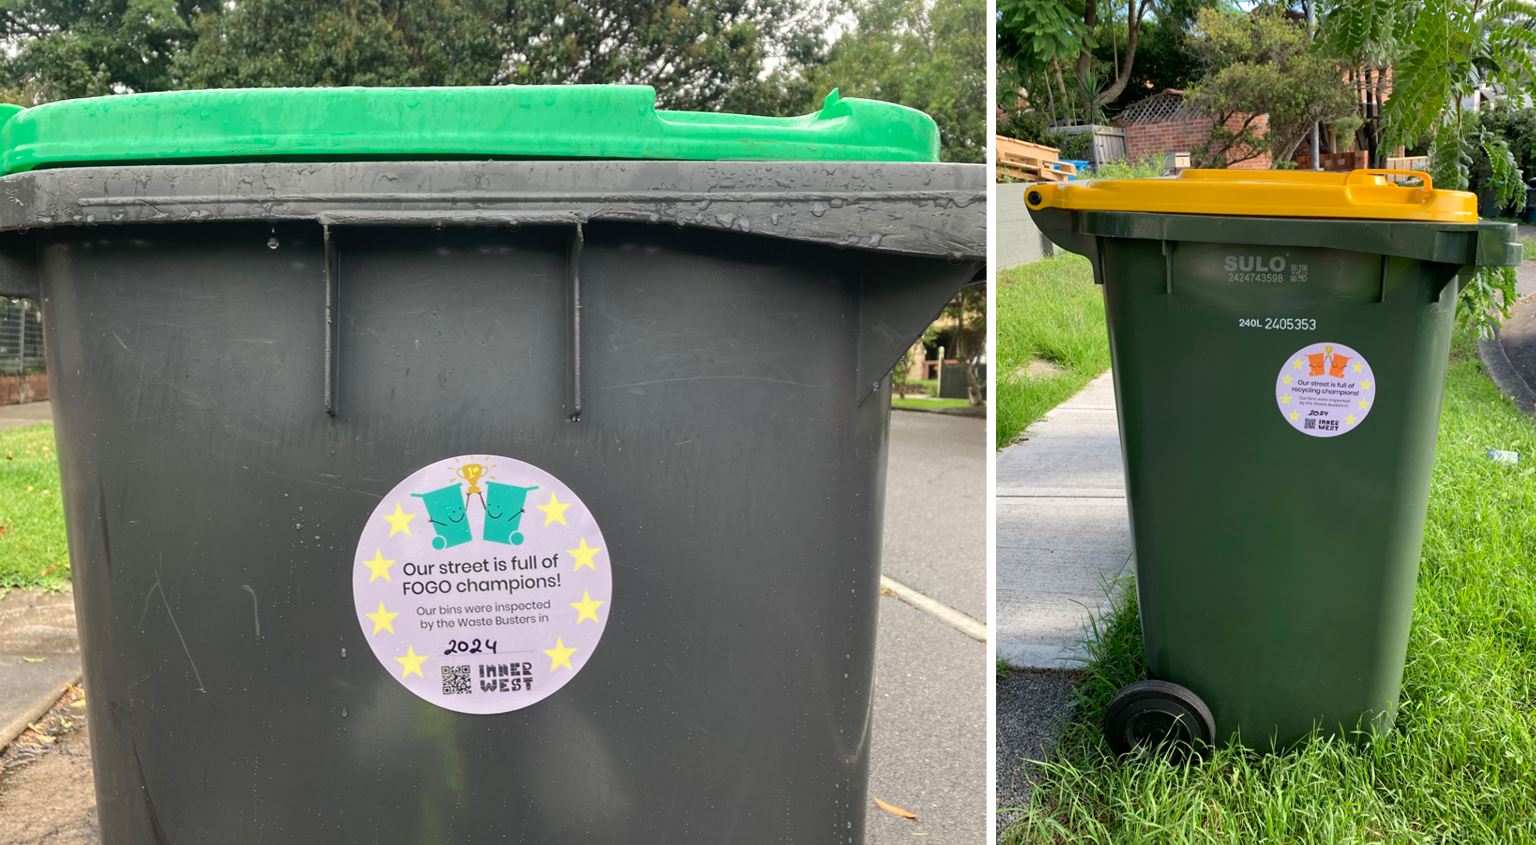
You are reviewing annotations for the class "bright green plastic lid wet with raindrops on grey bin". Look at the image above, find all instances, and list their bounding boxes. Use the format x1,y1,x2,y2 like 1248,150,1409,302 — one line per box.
0,85,938,174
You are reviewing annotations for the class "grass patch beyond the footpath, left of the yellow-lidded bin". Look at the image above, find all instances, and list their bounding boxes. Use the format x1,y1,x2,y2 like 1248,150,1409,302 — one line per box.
997,255,1109,449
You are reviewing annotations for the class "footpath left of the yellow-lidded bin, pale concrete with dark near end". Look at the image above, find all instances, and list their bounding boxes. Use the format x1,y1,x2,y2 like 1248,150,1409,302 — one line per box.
995,373,1132,830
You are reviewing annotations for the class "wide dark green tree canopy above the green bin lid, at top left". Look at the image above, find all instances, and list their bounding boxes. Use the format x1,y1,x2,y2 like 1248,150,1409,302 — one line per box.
0,0,829,114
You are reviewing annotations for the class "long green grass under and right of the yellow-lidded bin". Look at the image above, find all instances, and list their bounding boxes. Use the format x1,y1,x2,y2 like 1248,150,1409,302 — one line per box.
1001,332,1536,845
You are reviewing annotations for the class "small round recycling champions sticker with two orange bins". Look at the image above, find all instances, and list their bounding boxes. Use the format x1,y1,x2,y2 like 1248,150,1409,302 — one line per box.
1275,343,1376,438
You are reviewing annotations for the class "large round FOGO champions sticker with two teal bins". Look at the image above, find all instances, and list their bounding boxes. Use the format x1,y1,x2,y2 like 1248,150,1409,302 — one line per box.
352,455,613,713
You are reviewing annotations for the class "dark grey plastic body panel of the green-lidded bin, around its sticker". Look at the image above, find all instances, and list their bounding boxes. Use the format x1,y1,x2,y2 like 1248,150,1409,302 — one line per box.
37,223,975,845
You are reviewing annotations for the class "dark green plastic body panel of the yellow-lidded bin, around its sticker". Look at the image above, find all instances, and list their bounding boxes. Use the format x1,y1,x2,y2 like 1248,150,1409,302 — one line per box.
1098,238,1458,748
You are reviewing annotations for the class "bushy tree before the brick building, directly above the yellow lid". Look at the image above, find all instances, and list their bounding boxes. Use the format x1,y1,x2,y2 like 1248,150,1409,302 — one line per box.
1186,6,1355,167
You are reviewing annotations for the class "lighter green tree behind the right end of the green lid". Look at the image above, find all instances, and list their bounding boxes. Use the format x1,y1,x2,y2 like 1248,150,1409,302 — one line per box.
808,0,986,161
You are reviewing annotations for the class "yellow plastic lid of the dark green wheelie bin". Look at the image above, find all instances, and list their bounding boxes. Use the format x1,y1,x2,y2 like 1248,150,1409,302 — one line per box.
1025,167,1478,223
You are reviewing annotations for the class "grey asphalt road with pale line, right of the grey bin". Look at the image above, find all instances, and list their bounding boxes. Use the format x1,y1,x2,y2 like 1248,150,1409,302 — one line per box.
868,412,992,845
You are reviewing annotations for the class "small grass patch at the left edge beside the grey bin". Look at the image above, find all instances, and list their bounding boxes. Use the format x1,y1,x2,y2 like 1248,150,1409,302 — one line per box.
0,423,69,590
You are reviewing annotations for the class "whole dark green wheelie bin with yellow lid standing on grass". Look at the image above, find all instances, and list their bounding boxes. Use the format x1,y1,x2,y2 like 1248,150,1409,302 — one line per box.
1025,171,1521,751
